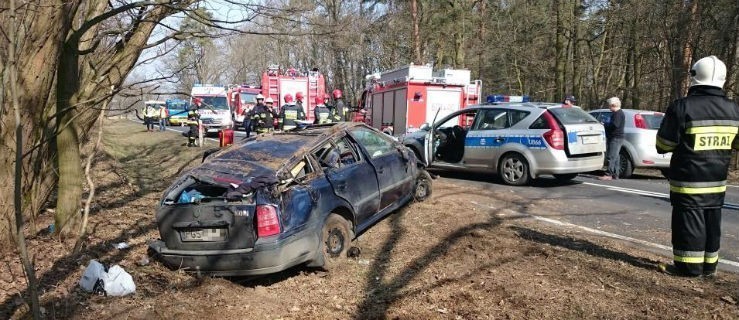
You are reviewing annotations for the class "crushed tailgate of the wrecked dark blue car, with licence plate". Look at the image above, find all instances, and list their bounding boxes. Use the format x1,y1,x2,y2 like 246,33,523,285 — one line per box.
156,162,277,251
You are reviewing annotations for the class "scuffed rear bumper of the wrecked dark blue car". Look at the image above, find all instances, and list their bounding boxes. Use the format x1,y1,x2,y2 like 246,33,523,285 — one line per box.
149,229,320,276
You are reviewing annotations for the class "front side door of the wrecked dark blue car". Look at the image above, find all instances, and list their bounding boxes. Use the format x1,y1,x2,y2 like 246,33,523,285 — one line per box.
349,127,414,210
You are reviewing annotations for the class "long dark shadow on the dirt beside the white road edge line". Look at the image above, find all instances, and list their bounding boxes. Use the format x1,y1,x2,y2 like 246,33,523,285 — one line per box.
511,226,659,270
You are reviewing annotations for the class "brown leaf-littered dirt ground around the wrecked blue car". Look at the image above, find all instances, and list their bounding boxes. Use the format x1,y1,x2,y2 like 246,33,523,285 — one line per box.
0,120,739,319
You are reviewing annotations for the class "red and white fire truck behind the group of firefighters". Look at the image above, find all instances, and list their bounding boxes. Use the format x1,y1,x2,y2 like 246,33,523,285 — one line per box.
262,65,326,121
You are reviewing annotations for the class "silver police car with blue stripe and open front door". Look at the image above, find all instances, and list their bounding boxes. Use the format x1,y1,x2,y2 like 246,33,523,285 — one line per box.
401,102,606,185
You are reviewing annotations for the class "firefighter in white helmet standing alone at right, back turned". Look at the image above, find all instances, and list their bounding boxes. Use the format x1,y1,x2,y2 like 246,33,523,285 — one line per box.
656,56,739,277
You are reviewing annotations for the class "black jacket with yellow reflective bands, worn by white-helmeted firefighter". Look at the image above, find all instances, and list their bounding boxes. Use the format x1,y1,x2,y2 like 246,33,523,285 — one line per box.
656,86,739,208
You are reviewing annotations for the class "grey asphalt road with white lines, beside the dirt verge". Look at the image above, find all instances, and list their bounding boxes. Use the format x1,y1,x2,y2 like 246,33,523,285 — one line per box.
434,171,739,272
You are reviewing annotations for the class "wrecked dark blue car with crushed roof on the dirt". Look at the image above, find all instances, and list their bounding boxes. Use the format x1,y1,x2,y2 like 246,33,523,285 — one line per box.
149,123,431,276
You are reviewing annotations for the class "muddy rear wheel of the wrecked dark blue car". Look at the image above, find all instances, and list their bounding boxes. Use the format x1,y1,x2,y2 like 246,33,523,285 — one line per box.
318,213,354,270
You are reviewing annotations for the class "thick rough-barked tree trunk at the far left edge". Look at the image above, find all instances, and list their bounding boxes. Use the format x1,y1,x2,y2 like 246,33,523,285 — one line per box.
0,1,73,246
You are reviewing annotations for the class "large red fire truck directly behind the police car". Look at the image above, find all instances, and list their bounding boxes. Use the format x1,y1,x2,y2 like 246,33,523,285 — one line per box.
353,65,482,135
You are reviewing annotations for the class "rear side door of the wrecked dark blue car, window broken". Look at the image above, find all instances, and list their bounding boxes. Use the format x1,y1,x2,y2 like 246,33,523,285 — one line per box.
313,136,380,224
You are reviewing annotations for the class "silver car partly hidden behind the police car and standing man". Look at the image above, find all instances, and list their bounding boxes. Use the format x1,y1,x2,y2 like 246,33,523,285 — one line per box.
589,109,672,178
